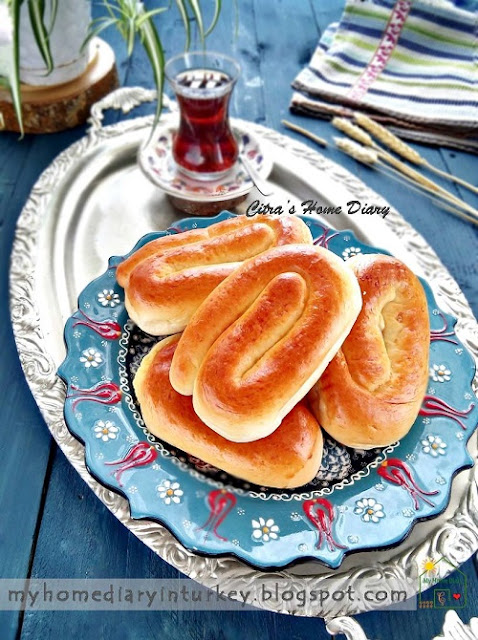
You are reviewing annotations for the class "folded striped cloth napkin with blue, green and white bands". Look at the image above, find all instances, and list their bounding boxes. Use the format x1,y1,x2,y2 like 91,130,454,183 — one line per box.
291,0,478,151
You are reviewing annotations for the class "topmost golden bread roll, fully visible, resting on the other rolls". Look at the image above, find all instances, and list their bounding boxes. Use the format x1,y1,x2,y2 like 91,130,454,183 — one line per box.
170,245,362,442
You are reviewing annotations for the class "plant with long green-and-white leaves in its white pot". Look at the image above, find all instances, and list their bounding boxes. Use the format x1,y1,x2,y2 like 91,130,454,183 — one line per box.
0,0,221,133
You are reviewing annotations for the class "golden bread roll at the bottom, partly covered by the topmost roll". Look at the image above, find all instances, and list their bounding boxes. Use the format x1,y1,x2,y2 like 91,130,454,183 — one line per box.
134,335,323,488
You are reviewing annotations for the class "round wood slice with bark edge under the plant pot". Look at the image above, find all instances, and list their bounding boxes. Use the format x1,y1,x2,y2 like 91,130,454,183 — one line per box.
0,38,118,133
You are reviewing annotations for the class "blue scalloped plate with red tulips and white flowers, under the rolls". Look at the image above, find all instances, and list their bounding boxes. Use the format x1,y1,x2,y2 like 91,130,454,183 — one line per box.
59,212,478,569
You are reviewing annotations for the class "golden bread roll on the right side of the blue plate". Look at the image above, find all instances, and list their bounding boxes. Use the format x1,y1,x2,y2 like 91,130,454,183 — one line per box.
309,255,430,449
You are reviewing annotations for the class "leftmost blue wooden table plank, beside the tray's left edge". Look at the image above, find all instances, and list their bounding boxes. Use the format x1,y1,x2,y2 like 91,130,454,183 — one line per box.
0,134,68,640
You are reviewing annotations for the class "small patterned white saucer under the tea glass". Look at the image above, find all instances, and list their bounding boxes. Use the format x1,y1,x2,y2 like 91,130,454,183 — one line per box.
138,125,272,202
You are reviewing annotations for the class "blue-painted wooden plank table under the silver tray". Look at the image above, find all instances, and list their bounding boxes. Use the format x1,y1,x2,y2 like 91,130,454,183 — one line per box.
0,0,478,640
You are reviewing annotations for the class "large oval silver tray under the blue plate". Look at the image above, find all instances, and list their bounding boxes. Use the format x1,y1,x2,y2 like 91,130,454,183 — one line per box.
10,88,478,637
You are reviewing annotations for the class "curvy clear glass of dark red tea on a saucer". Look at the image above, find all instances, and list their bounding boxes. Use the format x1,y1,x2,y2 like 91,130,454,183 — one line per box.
166,52,239,180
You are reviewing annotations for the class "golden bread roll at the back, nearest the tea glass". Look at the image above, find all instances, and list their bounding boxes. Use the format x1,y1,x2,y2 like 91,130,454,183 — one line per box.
116,216,312,335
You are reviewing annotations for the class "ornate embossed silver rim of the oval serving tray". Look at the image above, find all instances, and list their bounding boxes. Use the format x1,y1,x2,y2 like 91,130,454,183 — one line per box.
10,100,478,619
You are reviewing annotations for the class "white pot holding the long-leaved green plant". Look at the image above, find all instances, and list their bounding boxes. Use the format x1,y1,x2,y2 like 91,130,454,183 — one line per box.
20,0,91,86
